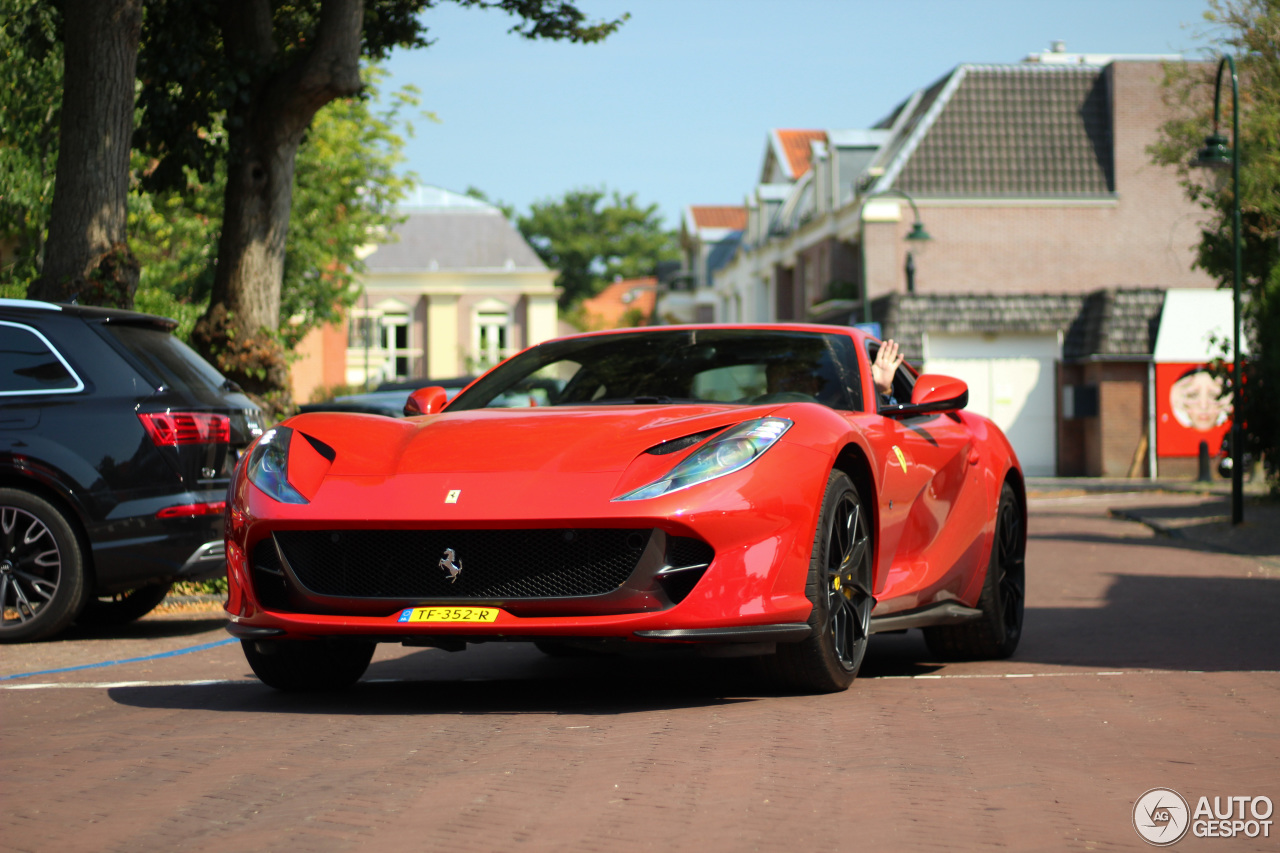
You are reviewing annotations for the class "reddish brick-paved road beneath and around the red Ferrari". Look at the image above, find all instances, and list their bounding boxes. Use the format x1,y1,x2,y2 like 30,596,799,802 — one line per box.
0,496,1280,853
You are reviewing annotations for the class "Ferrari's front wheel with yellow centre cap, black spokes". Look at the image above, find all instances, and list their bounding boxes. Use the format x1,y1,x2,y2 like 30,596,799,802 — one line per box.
773,471,876,693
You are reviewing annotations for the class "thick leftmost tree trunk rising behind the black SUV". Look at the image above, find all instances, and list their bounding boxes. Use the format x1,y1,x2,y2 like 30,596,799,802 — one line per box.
27,0,142,307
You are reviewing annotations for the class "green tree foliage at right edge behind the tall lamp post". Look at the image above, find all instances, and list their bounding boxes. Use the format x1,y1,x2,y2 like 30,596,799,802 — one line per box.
1151,0,1280,485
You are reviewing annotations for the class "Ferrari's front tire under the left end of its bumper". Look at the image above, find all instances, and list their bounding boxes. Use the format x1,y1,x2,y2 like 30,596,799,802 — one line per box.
241,640,376,692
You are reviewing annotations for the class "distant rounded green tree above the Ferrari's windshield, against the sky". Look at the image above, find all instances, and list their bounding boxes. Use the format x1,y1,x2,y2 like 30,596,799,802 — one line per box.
516,188,680,310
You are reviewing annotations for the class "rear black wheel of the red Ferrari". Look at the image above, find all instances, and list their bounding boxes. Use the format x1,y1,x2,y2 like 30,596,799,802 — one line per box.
924,483,1027,661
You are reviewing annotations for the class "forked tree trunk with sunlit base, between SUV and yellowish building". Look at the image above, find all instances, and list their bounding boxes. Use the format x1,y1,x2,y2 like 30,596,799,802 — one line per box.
192,0,364,414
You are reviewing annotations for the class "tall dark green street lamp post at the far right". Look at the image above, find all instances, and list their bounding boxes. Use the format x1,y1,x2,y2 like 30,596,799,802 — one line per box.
1192,56,1244,524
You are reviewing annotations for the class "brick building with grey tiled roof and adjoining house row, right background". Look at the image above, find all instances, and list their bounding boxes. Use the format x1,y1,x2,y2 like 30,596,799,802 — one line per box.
691,51,1216,476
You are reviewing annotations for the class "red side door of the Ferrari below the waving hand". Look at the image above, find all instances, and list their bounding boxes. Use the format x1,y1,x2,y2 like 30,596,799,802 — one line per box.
865,350,991,615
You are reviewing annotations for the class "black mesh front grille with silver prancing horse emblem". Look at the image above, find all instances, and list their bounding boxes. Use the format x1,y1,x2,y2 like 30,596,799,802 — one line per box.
268,529,653,599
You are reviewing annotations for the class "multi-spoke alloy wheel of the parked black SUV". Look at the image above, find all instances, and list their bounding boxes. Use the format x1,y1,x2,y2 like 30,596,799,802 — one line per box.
0,489,84,643
